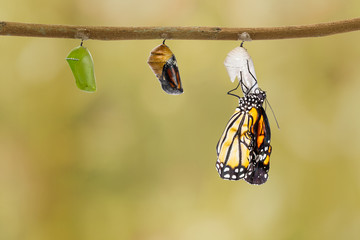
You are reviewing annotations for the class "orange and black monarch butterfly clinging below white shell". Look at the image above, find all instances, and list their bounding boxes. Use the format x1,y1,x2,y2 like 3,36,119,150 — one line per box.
216,61,272,185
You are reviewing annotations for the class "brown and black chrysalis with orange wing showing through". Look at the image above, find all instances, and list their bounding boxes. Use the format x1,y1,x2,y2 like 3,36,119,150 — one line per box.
148,43,184,95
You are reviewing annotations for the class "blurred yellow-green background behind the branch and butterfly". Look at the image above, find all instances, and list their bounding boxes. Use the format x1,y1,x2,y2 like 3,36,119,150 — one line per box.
0,0,360,240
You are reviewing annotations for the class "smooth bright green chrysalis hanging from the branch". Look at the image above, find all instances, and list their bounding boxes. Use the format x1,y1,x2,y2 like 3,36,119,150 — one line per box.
66,46,96,92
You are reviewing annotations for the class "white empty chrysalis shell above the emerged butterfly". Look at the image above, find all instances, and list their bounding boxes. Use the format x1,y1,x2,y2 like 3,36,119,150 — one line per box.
224,47,258,94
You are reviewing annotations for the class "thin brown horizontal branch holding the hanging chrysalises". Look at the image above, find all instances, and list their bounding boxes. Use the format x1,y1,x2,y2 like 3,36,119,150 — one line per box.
0,18,360,40
